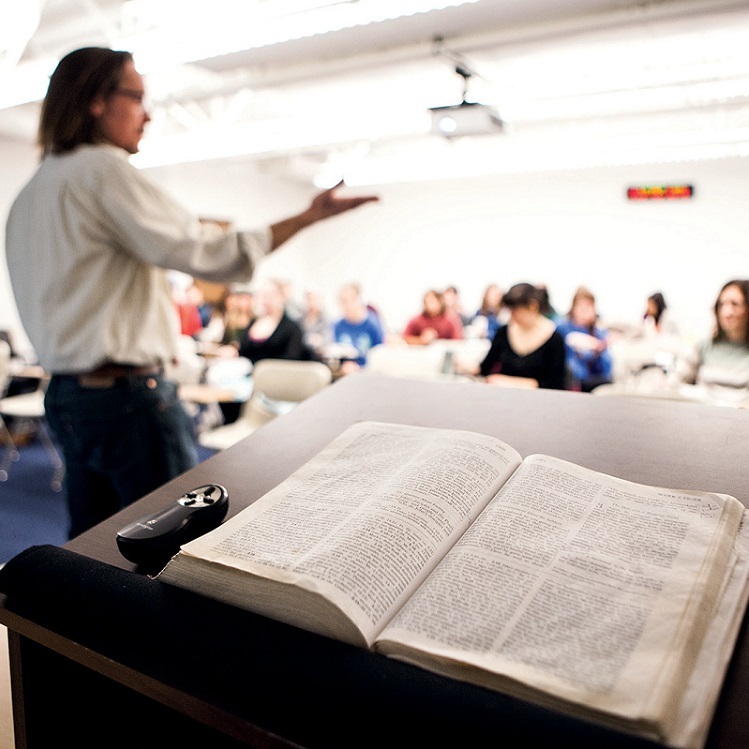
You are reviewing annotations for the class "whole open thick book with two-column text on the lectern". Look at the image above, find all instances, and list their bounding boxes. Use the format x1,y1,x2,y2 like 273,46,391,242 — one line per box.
158,422,749,747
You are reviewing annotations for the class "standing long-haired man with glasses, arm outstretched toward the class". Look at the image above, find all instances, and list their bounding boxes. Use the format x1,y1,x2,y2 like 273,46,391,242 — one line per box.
6,47,375,537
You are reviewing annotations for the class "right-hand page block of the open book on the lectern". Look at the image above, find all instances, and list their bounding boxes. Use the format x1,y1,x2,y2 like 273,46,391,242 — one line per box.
376,456,745,739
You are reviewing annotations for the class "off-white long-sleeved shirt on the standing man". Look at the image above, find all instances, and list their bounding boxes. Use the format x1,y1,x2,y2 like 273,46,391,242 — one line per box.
5,145,272,373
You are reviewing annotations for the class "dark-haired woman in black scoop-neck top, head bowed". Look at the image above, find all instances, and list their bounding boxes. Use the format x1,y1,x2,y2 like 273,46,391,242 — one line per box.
478,283,567,390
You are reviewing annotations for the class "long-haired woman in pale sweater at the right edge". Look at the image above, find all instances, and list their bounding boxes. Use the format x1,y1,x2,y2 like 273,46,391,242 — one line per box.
676,279,749,395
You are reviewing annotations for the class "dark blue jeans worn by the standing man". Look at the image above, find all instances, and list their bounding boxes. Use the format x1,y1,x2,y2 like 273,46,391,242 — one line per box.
45,375,197,538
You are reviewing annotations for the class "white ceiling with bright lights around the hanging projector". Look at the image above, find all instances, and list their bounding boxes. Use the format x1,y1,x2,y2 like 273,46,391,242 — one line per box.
0,0,749,183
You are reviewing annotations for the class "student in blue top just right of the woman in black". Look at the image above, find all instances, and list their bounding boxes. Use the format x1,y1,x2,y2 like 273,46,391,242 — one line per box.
557,286,614,393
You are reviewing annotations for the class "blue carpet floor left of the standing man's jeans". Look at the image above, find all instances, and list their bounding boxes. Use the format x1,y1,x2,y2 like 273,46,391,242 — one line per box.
0,430,210,564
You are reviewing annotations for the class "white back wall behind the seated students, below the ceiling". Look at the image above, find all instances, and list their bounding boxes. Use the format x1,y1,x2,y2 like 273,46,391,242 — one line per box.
0,146,749,362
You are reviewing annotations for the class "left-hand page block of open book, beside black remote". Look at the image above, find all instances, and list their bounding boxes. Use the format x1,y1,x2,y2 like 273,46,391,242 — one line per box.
160,422,521,644
